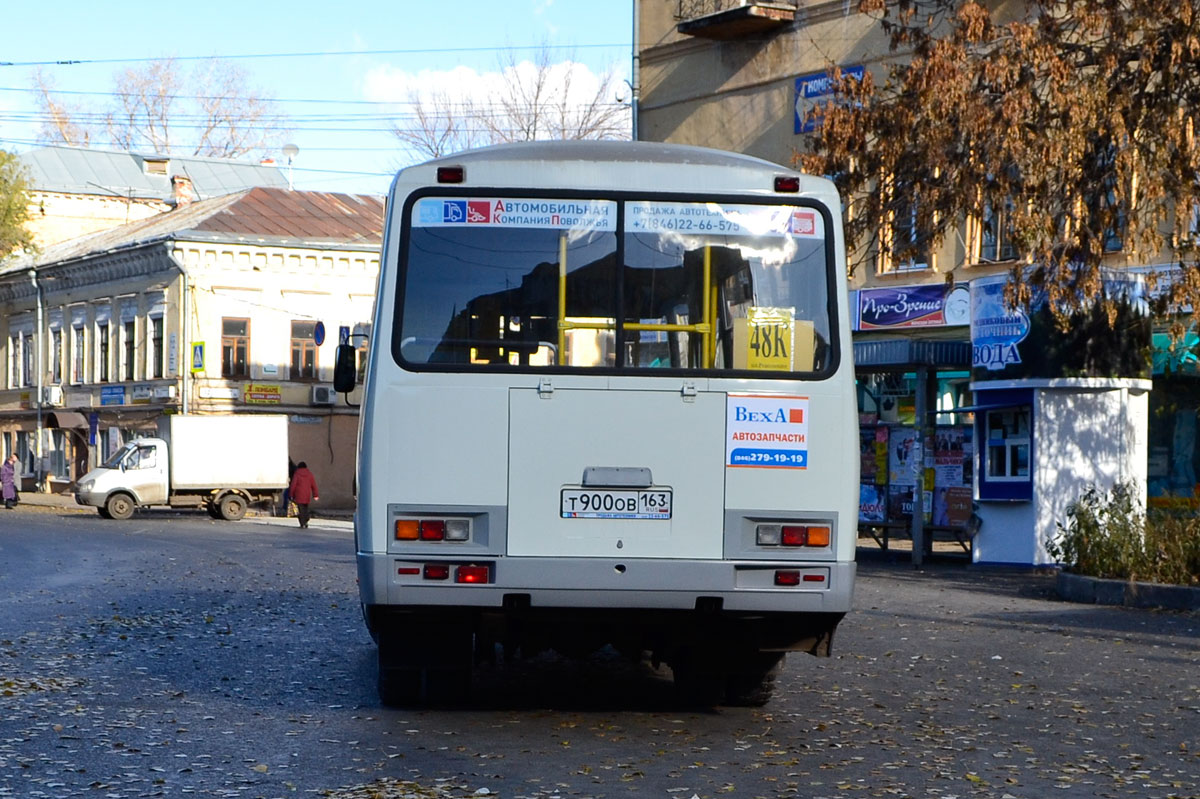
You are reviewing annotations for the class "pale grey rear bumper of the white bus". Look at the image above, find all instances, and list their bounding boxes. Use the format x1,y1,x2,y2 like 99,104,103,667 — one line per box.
358,552,856,614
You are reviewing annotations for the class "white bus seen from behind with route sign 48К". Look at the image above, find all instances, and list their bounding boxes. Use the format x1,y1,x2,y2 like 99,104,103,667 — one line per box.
337,142,859,704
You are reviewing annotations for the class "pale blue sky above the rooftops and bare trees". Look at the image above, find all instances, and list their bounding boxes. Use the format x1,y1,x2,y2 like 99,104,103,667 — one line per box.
0,0,632,193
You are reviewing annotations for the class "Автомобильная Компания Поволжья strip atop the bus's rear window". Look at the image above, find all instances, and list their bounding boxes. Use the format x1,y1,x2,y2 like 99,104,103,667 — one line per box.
413,197,617,230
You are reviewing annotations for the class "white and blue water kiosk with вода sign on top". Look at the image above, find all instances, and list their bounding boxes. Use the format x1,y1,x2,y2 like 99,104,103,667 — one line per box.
971,277,1151,566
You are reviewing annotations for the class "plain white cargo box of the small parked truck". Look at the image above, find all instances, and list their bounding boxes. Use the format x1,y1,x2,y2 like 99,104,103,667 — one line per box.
158,414,288,492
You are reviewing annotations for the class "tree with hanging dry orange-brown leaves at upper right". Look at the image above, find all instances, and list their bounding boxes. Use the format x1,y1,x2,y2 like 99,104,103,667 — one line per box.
798,0,1200,321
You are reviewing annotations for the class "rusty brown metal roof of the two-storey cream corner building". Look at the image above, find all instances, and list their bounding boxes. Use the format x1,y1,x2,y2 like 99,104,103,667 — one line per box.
0,188,384,275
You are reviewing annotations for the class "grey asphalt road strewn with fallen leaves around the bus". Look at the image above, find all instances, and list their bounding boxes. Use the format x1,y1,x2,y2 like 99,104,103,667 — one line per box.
0,511,1200,799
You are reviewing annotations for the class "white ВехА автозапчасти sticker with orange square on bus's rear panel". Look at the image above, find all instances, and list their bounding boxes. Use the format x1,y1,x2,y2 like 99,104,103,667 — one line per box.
725,394,809,469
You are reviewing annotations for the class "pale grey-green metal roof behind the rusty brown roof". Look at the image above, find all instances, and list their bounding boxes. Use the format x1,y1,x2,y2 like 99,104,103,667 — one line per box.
18,145,288,202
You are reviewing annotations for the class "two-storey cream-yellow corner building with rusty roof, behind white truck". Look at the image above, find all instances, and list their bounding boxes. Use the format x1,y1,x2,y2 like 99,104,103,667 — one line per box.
0,188,383,506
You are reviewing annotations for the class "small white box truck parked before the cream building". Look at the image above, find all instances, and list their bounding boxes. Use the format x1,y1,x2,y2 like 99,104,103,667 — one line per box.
76,414,288,521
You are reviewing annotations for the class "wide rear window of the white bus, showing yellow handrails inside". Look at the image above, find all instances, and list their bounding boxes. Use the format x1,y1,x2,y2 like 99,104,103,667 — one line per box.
392,197,835,376
